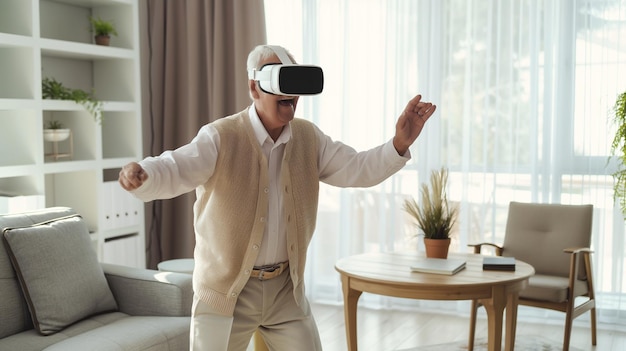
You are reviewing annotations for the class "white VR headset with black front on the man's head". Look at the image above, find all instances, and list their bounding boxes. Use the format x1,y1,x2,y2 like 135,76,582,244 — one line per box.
248,46,324,96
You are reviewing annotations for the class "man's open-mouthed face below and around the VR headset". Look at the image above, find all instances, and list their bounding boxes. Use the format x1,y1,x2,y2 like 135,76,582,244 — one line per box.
248,56,298,135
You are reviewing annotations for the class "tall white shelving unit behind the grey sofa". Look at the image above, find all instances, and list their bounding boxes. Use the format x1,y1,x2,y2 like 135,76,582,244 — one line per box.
0,0,145,267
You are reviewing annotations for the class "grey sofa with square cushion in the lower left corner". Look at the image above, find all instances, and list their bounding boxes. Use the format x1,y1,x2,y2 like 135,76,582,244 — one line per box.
0,207,192,351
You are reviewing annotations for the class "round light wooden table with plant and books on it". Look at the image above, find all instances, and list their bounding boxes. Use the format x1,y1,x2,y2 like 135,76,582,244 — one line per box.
335,252,535,351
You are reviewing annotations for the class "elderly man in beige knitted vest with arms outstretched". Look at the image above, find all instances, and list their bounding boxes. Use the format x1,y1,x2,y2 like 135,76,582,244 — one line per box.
119,45,436,351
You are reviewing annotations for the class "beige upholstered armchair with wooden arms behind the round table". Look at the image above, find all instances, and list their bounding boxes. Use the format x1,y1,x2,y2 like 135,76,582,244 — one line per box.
469,202,596,350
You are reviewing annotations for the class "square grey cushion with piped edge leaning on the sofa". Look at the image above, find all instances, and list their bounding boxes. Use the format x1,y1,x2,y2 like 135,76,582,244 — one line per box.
3,215,117,335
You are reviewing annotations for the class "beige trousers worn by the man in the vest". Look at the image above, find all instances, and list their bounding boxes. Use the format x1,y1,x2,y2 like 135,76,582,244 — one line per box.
190,270,322,351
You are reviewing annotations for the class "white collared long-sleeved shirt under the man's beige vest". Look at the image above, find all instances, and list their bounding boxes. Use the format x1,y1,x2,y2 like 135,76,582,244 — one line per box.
133,104,410,266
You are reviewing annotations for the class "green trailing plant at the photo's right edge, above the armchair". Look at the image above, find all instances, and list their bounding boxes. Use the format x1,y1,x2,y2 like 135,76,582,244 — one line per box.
611,91,626,217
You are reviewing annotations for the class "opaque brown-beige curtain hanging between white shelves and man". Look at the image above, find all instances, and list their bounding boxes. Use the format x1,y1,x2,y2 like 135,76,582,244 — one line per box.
139,0,266,268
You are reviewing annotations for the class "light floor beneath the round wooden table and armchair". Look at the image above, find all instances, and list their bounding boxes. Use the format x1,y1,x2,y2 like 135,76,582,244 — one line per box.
248,304,626,351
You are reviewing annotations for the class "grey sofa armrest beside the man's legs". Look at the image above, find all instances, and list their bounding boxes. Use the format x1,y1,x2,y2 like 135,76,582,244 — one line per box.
101,263,193,316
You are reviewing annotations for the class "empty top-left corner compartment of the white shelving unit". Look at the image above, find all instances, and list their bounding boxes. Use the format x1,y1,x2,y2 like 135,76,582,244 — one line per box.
0,0,33,36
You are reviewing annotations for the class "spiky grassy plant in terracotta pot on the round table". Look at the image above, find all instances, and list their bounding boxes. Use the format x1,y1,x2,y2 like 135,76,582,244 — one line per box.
403,168,457,258
